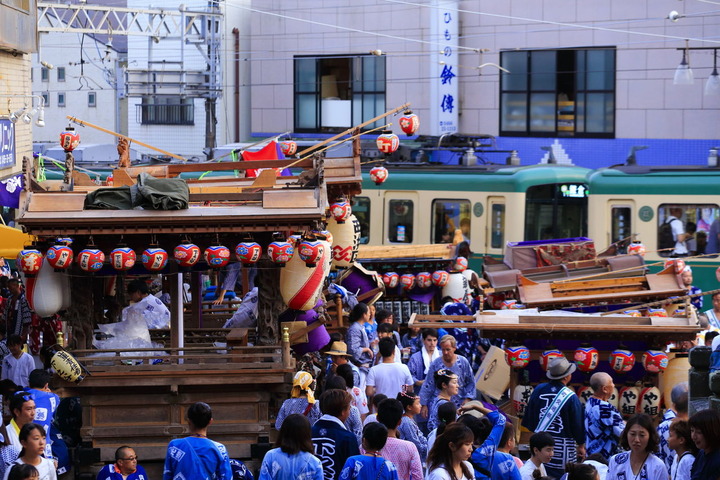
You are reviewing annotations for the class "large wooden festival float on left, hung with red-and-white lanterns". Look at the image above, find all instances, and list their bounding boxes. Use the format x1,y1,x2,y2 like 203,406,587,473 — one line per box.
12,105,422,471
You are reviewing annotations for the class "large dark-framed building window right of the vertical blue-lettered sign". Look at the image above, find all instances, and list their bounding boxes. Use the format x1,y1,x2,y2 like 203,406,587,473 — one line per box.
500,48,615,138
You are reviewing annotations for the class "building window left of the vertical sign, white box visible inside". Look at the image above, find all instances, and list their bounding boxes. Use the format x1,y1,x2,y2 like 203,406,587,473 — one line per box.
294,55,385,132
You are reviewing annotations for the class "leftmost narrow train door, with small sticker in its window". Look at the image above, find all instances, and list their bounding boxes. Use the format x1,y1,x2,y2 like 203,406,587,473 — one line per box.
383,191,416,244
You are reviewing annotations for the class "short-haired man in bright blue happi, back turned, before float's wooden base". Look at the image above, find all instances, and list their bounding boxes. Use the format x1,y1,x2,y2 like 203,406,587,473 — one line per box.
163,402,232,480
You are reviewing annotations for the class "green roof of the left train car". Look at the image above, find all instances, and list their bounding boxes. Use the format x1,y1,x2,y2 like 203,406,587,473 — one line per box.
363,164,591,192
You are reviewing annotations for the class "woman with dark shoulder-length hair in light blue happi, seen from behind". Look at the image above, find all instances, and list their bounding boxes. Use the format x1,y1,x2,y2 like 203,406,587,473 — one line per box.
259,413,323,480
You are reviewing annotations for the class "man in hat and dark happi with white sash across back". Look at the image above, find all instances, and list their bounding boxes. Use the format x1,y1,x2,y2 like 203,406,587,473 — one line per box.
522,357,585,478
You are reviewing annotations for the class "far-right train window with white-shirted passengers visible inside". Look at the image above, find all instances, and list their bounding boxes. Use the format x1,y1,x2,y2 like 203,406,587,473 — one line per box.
657,203,720,257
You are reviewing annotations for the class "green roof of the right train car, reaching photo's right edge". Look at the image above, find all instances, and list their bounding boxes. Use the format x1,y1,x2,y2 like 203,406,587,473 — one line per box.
588,165,720,195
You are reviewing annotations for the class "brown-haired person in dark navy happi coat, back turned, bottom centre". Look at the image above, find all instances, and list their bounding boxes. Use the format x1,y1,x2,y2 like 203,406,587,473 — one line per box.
312,388,360,480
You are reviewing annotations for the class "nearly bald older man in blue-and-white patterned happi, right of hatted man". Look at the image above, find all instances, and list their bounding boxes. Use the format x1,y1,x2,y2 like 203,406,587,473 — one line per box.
585,372,625,459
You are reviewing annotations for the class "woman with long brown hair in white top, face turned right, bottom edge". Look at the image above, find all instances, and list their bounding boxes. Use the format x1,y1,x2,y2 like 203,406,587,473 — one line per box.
426,422,475,480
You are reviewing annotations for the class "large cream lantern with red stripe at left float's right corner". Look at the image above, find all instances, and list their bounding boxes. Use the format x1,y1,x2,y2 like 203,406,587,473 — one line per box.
280,242,331,311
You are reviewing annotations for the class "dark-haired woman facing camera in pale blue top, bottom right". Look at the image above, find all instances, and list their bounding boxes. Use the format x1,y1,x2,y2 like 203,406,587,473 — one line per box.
607,413,668,480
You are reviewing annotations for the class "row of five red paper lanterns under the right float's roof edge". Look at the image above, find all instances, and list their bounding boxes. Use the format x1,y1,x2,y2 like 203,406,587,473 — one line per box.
505,345,668,373
